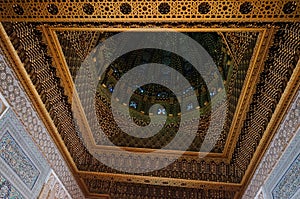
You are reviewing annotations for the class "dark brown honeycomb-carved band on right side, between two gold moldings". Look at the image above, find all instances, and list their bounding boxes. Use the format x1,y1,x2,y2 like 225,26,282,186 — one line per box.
232,23,300,173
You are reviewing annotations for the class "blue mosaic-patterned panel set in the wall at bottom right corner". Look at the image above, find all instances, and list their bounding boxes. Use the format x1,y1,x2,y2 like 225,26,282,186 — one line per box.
272,154,300,199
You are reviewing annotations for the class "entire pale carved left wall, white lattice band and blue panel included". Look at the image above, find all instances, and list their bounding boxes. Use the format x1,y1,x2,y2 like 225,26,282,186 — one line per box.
0,49,84,199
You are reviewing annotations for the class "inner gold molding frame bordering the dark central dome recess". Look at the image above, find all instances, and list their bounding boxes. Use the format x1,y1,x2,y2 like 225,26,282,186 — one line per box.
41,26,264,162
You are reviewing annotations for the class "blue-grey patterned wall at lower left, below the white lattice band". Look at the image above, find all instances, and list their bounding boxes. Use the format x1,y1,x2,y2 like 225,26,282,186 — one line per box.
0,93,71,199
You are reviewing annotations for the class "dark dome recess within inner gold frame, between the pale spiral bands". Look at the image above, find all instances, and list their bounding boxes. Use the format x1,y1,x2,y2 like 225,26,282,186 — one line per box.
54,29,255,155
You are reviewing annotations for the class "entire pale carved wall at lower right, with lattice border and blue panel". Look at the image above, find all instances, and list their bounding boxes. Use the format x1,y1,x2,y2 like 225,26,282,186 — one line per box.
243,91,300,199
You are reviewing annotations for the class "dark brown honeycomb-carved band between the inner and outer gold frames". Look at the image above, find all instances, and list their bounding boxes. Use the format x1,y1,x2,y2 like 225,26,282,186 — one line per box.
4,20,300,198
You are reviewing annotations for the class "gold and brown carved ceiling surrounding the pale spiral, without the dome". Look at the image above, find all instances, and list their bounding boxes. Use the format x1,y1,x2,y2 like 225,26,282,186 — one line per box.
0,0,300,199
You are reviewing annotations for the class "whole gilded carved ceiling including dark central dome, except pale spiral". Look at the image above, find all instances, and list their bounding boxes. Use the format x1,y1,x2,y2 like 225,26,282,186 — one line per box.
0,0,300,199
